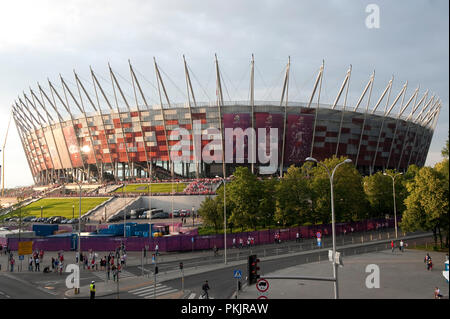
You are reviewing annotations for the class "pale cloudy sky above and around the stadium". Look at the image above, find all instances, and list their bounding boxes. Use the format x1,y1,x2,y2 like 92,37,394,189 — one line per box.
0,0,449,187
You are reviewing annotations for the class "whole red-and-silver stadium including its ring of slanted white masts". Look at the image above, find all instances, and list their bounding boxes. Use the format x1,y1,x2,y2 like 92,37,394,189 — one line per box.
12,58,441,185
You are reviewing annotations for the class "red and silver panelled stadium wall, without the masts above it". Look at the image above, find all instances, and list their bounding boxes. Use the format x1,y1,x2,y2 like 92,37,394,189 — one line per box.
14,103,433,184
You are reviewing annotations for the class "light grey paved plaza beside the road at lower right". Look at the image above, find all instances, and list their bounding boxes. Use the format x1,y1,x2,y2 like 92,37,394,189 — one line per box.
239,250,449,299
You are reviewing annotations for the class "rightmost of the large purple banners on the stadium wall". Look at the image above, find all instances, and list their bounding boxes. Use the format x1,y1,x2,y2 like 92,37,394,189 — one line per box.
284,114,314,164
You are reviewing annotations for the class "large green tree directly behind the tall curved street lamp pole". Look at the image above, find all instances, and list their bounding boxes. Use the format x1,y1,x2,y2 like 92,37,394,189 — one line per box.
311,156,370,223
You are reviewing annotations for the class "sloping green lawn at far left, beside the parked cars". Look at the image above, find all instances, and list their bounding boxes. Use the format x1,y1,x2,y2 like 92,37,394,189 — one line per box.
1,197,109,219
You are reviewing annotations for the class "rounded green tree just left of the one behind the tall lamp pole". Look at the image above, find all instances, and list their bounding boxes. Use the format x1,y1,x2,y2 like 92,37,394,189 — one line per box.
275,166,311,226
